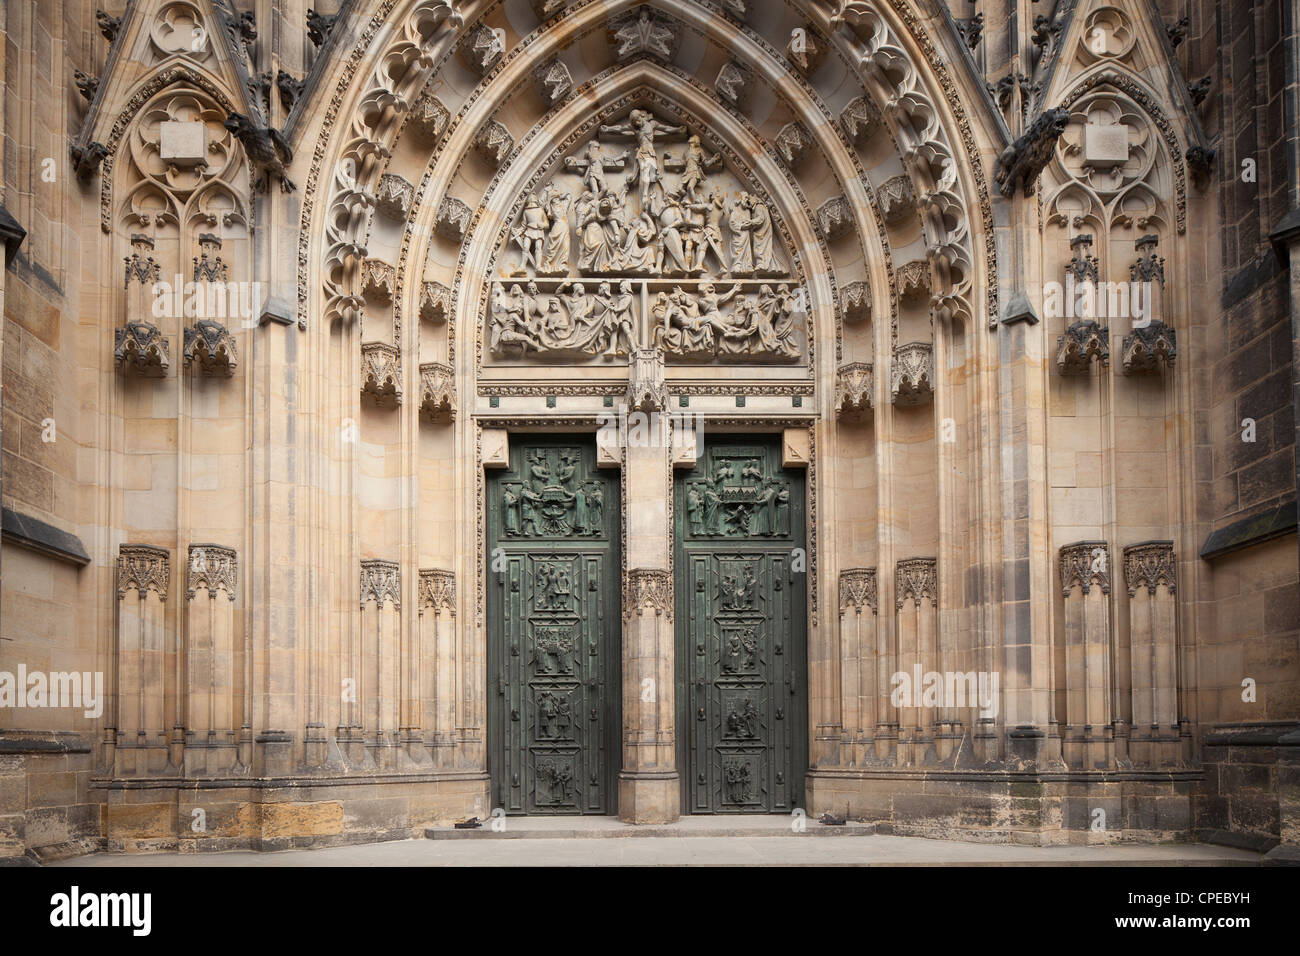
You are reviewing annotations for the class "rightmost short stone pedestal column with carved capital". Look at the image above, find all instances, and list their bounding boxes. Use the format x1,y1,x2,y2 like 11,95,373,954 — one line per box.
1125,541,1180,767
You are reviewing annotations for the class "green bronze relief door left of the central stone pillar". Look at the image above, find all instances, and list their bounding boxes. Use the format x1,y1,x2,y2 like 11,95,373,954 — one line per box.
486,438,621,814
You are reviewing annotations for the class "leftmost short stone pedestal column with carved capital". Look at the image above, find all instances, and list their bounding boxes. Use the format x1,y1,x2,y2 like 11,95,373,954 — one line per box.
113,545,172,777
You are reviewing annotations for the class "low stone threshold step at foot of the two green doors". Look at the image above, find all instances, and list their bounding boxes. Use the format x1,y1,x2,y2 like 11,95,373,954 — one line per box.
424,814,875,840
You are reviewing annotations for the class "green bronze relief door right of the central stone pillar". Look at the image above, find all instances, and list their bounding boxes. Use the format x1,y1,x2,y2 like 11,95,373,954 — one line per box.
675,437,807,813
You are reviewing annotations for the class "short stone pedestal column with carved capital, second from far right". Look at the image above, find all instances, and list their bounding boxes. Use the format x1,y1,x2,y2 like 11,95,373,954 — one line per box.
1061,541,1114,770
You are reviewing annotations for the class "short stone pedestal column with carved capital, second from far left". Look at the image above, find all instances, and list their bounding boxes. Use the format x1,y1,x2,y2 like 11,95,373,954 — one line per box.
183,545,243,775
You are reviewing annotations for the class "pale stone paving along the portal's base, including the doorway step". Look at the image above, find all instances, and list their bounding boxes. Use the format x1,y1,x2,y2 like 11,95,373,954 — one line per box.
53,817,1261,866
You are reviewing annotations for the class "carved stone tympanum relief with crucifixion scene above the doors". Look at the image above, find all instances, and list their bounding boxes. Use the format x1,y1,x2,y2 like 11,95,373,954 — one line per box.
486,109,806,364
